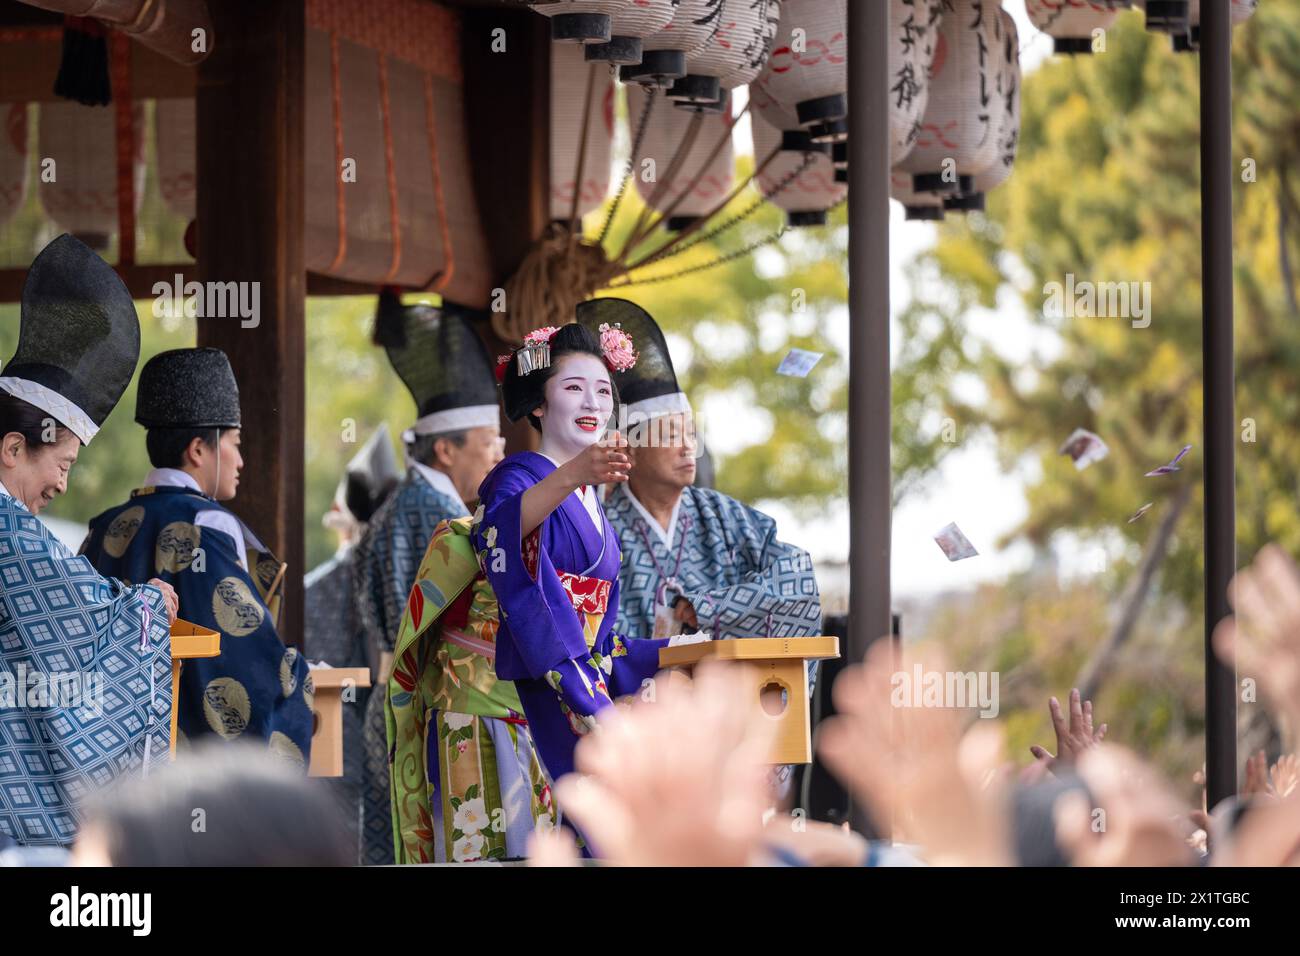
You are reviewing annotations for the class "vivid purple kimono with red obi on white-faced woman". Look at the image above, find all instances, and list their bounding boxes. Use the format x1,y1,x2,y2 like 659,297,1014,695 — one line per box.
472,451,667,785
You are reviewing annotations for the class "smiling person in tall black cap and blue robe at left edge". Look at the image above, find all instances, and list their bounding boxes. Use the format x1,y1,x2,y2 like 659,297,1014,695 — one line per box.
0,235,176,845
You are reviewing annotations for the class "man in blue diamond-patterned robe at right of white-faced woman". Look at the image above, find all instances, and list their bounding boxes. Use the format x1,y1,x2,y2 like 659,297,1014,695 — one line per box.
579,306,822,650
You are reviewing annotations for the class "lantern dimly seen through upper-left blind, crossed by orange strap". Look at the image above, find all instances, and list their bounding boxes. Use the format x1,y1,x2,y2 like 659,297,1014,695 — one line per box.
38,100,144,251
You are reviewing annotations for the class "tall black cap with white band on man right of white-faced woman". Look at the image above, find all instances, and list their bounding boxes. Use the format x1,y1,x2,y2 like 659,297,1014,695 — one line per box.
576,299,690,420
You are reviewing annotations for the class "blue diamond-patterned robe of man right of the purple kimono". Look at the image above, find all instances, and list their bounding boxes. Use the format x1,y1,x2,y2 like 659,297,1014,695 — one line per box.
605,484,822,650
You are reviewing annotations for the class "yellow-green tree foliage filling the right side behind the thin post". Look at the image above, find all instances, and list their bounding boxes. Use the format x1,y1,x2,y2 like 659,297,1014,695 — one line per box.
896,4,1300,773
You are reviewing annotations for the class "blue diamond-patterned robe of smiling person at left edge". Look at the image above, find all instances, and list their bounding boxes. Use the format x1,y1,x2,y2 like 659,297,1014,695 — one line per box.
0,492,172,845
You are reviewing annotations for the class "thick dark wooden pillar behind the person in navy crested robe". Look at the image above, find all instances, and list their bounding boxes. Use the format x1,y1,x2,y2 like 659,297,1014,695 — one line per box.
196,0,307,646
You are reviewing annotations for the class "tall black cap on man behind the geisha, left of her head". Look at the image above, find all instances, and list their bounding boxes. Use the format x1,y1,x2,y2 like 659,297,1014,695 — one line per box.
374,289,501,441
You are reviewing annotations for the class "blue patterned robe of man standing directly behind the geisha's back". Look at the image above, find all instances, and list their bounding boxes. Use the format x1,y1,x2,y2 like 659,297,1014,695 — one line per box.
352,466,469,866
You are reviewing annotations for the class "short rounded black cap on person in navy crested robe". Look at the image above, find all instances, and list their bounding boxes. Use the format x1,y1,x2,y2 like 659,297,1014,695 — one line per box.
135,349,241,428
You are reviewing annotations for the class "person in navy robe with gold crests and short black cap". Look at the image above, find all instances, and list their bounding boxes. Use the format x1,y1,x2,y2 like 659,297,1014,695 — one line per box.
82,349,313,771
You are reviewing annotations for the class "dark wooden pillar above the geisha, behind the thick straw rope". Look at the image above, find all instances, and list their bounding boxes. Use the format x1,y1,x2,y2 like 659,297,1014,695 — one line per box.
460,8,551,454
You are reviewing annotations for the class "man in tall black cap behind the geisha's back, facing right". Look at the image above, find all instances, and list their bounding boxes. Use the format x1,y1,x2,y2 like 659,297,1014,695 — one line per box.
352,290,503,865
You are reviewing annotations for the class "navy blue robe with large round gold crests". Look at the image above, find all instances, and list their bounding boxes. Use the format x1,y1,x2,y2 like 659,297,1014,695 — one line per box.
82,485,313,770
